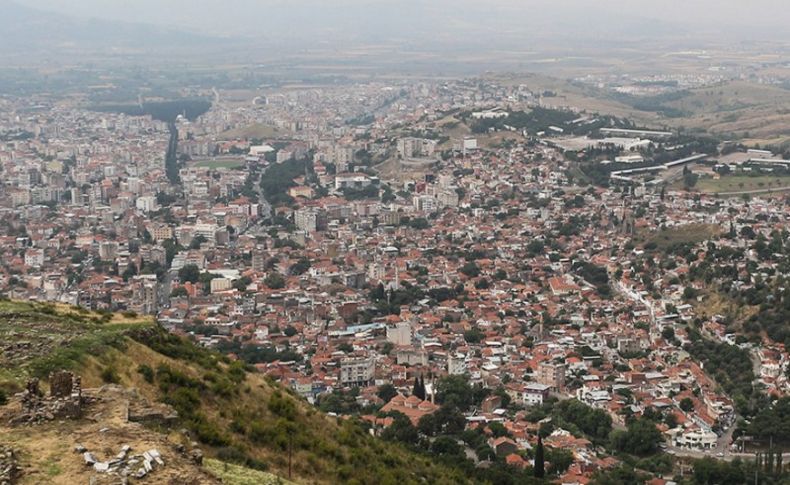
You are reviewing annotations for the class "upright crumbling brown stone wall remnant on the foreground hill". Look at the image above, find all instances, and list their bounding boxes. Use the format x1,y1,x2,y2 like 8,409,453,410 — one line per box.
11,370,88,424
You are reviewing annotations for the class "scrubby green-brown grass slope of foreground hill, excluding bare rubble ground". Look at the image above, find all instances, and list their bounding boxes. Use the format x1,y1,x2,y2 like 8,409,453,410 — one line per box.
0,302,467,484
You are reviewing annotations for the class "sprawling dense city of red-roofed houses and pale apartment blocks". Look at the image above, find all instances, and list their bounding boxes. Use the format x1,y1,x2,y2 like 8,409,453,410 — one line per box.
0,80,790,484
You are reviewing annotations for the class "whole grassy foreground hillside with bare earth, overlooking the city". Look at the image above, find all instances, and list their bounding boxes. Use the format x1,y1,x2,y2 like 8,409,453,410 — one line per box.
0,301,466,484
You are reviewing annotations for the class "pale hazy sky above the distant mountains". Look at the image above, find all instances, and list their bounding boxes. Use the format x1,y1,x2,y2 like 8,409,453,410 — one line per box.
10,0,790,36
